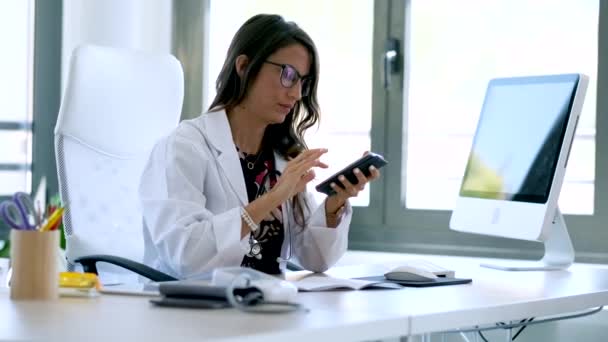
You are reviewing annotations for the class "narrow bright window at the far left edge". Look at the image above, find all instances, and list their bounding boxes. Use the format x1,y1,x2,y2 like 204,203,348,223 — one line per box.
0,0,34,196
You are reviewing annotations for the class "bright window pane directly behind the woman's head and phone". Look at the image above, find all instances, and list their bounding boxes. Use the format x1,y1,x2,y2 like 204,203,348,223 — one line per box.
204,0,374,206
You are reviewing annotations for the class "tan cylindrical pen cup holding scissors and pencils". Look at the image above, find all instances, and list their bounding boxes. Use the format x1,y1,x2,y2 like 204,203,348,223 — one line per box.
10,229,59,300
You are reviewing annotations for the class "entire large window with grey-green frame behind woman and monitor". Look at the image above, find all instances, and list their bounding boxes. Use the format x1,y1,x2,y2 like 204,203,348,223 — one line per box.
198,0,608,262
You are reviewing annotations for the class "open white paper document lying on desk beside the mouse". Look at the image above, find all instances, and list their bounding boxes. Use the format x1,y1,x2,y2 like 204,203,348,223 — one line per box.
289,273,403,292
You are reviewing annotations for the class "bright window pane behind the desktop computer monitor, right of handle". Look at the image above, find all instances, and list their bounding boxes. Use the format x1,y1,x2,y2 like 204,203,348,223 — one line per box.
403,0,599,214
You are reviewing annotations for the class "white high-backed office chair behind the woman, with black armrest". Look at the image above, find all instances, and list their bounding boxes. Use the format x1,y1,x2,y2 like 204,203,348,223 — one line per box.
55,45,184,283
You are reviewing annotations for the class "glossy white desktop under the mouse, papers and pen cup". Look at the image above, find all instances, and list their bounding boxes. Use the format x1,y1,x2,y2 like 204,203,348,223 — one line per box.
0,252,608,342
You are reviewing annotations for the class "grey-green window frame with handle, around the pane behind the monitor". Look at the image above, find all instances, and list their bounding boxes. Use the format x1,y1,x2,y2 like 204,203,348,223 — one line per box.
349,0,608,263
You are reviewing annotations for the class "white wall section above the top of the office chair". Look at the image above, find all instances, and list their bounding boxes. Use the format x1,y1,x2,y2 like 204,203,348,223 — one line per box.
61,0,172,89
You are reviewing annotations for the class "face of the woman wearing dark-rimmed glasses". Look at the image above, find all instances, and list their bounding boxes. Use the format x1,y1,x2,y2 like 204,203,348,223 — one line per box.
241,44,311,124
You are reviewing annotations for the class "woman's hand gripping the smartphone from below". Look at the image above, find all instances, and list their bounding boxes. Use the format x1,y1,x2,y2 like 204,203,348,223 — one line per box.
325,152,380,215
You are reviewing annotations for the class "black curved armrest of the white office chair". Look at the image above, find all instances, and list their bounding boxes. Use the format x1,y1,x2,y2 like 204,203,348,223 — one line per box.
74,254,177,282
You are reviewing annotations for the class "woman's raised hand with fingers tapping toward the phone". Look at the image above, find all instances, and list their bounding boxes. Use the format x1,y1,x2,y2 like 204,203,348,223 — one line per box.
271,148,327,201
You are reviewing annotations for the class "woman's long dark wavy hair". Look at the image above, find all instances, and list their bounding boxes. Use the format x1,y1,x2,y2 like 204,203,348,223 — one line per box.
209,14,320,226
